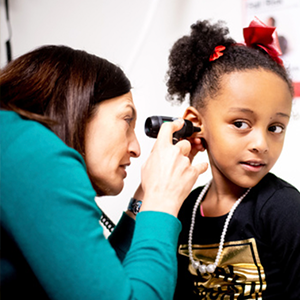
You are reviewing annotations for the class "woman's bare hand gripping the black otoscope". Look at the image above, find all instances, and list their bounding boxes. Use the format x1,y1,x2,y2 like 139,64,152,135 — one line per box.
141,119,208,216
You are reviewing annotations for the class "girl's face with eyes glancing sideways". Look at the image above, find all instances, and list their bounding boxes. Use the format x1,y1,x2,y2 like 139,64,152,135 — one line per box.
200,70,292,188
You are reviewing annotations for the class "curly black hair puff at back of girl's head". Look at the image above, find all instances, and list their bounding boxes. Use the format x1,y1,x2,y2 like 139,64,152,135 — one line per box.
167,20,235,102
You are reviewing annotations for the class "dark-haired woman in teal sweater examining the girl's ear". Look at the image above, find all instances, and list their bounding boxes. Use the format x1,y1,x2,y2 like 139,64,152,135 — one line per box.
0,46,207,300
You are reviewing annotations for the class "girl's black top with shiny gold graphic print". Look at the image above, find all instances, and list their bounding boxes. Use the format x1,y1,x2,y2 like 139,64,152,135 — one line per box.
174,173,300,300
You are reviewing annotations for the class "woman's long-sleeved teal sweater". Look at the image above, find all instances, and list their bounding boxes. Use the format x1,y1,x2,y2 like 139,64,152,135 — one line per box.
0,111,181,300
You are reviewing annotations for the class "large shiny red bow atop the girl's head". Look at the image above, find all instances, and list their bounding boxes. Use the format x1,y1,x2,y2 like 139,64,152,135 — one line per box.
243,17,283,66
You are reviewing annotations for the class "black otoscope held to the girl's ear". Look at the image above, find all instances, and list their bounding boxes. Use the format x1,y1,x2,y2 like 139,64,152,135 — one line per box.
145,116,201,144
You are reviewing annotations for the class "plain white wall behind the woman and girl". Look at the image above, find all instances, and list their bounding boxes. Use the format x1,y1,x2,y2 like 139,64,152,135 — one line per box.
0,0,300,225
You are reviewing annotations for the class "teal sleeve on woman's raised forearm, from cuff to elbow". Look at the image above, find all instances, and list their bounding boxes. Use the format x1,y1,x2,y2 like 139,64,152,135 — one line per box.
124,211,181,299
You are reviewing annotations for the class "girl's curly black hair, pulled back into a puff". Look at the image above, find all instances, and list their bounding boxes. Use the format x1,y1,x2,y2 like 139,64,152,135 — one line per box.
167,20,293,108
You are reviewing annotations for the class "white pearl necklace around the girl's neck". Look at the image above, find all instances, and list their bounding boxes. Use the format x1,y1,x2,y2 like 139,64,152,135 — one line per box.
188,181,251,274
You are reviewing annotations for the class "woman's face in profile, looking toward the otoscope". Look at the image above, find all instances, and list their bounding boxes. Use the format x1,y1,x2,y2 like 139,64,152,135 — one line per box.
85,92,140,195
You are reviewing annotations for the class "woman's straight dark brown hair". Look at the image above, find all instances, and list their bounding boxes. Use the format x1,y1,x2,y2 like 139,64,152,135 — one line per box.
0,46,131,154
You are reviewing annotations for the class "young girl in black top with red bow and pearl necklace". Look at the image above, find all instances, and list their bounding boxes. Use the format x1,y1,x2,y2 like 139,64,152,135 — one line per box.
167,19,300,299
